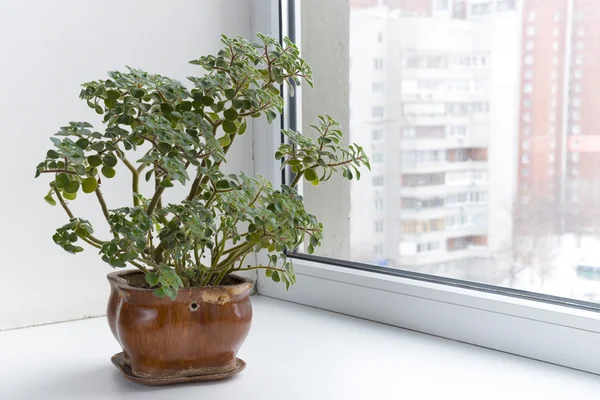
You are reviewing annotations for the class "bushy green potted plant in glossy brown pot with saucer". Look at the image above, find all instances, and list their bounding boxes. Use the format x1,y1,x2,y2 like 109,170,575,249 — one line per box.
36,35,369,384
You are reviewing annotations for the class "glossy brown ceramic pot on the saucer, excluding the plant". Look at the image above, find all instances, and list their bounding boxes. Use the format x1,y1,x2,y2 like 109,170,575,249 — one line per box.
107,271,252,378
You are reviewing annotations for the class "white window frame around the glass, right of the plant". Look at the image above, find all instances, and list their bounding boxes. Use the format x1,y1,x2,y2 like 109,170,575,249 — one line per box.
252,0,600,374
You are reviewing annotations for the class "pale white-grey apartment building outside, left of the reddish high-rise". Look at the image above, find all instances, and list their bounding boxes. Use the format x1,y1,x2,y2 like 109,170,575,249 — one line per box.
350,0,521,277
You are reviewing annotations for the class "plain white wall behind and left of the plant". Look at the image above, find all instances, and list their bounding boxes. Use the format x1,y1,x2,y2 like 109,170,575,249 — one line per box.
0,0,252,330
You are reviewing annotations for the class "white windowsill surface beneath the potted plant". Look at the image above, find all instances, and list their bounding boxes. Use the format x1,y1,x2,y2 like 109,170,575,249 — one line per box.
0,296,600,400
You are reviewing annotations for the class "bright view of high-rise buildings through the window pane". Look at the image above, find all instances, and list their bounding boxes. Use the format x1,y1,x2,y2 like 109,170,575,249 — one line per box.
300,0,600,299
